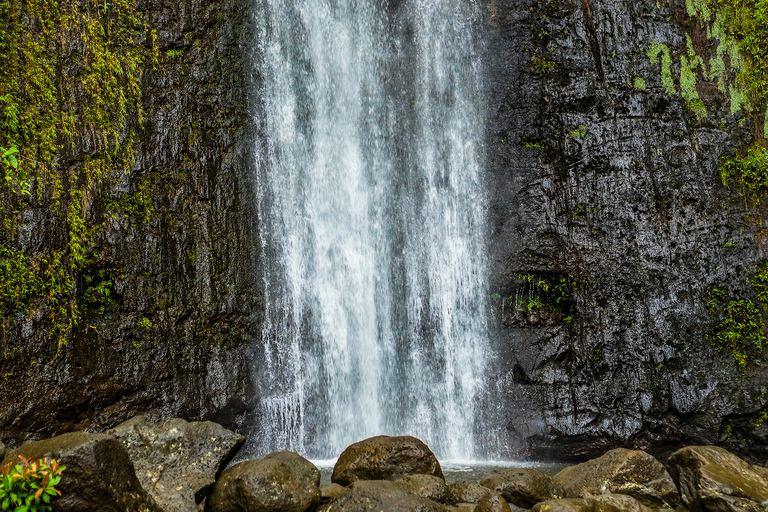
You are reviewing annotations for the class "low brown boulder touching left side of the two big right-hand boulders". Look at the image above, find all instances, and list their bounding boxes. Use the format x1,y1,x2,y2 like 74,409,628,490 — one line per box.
480,469,563,508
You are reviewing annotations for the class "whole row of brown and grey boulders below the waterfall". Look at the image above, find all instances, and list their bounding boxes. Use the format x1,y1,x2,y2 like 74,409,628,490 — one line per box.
0,416,768,512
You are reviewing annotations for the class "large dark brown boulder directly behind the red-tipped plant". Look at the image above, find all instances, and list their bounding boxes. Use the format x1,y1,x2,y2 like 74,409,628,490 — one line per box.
0,432,162,512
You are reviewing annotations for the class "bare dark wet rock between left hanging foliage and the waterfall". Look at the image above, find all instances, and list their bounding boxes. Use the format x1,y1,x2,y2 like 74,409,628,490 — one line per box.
0,0,262,446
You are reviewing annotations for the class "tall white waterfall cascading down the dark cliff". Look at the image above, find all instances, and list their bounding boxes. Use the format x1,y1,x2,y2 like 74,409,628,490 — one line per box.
253,0,489,458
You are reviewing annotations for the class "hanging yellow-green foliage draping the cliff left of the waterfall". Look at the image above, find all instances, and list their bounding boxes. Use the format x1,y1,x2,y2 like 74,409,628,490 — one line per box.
0,0,157,352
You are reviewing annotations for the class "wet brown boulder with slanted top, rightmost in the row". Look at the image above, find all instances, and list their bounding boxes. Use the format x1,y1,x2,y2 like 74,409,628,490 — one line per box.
667,446,768,512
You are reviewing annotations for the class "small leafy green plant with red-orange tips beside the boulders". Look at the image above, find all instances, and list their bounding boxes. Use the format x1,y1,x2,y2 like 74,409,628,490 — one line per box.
0,456,66,512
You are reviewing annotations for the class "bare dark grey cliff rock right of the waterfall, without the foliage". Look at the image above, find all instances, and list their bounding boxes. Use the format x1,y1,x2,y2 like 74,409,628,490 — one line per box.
487,0,768,458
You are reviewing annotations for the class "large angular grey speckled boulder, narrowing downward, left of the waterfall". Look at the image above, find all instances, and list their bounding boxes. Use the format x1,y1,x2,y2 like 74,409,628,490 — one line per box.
107,416,245,512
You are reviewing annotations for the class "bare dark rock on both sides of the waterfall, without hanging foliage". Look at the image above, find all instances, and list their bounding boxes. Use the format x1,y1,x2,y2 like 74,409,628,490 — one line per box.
0,0,768,458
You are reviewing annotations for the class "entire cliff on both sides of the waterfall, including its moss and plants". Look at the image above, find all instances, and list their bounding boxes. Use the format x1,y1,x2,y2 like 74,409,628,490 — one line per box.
0,0,768,464
